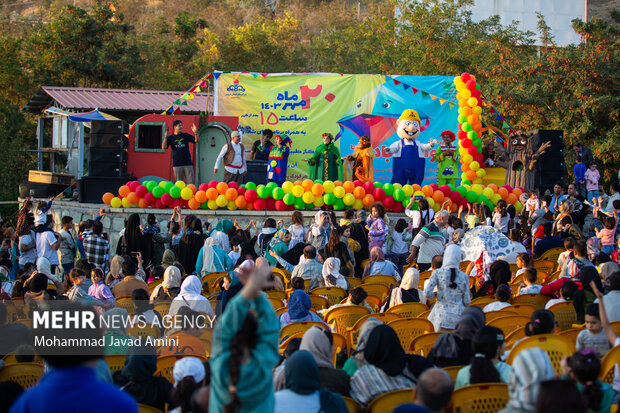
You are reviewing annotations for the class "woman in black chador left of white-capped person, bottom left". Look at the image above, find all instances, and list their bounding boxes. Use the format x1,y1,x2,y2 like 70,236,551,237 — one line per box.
112,347,172,412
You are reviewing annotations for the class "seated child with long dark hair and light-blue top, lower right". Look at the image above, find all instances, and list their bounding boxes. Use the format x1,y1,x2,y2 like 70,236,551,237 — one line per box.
454,326,512,389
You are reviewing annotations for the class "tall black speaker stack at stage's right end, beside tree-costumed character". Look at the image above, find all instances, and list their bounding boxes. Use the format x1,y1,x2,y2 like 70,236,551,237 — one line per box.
532,129,566,193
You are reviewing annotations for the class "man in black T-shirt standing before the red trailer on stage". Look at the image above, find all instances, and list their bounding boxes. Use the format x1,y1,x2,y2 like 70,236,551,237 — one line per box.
161,120,199,184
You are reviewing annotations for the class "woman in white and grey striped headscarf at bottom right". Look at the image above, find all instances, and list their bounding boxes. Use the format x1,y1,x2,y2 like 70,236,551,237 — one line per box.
499,347,555,413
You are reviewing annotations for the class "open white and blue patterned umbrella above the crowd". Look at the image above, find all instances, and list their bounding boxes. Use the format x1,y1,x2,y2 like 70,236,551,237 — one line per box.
460,225,515,262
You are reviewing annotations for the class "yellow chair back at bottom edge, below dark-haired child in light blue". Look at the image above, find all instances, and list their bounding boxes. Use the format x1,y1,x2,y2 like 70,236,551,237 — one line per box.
452,383,510,413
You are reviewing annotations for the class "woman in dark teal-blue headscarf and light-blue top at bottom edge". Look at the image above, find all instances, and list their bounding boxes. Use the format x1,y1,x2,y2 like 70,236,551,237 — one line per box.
274,350,348,413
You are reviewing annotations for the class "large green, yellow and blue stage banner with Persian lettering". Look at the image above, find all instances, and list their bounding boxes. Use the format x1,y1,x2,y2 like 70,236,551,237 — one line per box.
214,72,458,184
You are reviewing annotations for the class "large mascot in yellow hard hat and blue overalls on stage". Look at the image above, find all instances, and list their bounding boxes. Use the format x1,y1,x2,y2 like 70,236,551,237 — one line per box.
386,109,437,185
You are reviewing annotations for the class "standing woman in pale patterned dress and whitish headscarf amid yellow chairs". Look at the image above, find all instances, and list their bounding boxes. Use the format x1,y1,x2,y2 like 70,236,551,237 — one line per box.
424,244,471,331
